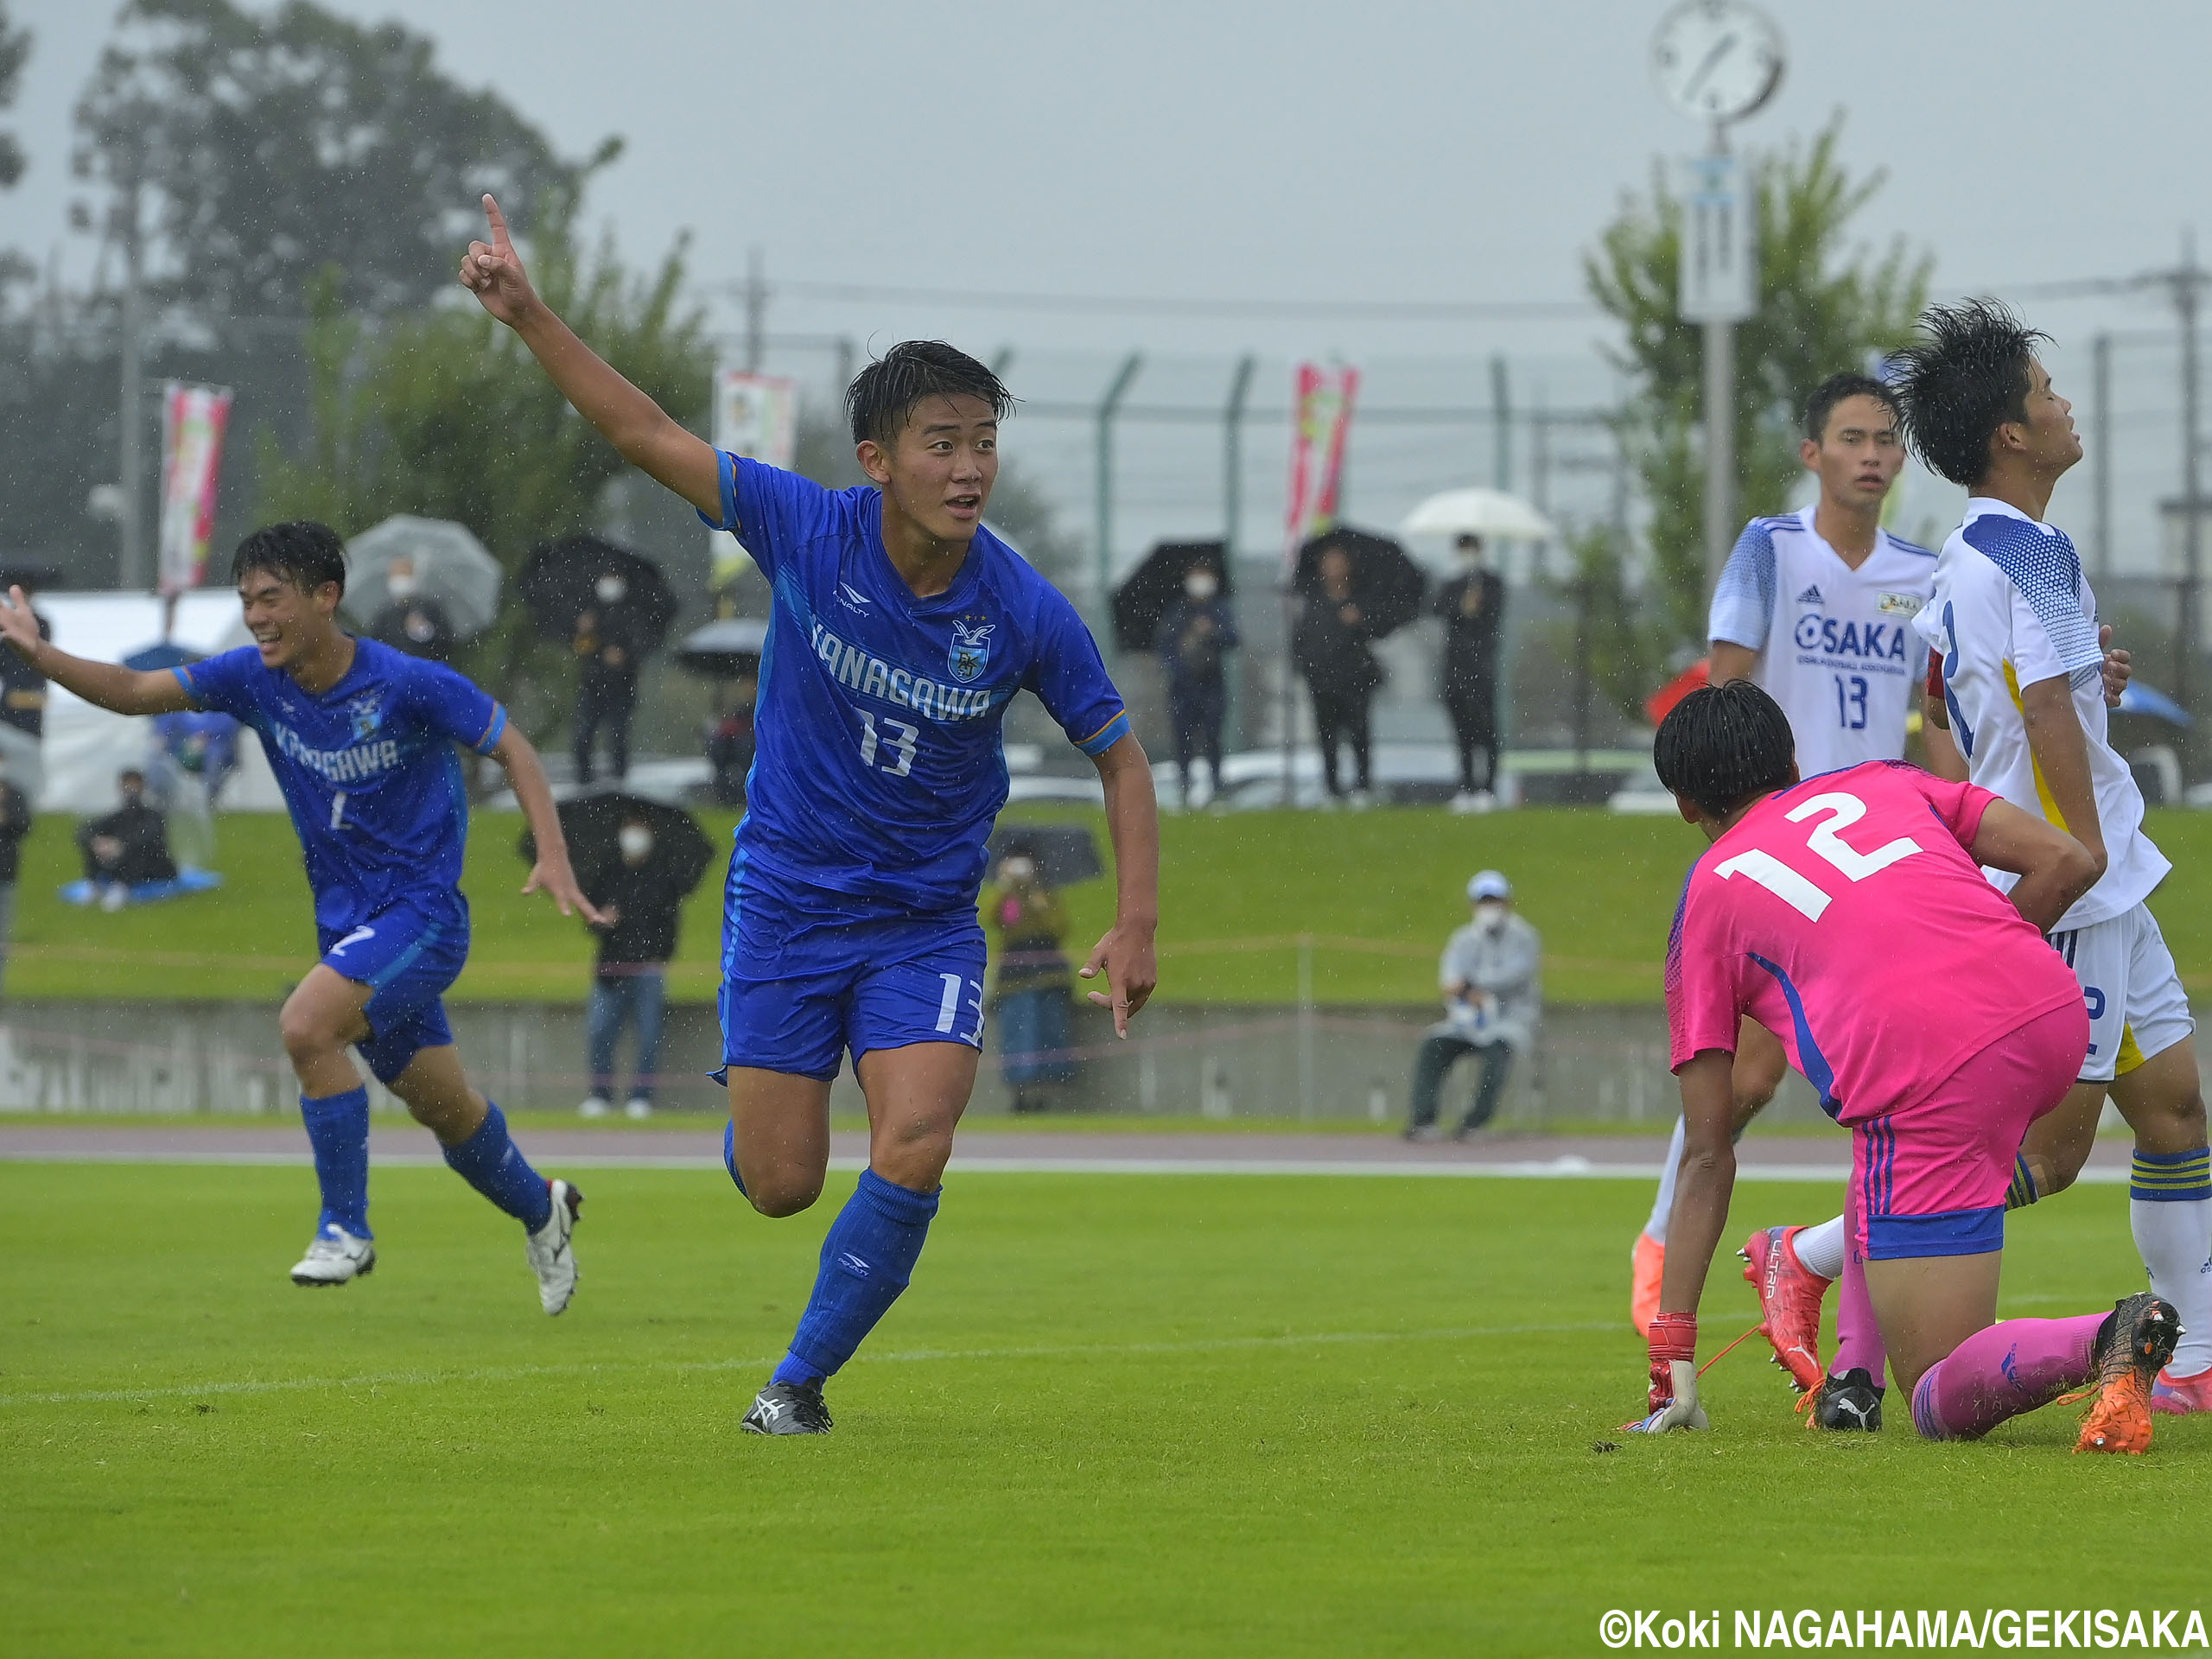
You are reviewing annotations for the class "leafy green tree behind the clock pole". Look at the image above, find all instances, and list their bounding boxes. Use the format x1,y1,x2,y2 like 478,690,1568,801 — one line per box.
1577,115,1936,712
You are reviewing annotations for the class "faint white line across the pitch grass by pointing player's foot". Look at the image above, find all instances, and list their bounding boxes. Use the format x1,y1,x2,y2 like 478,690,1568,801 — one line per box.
0,1319,1617,1407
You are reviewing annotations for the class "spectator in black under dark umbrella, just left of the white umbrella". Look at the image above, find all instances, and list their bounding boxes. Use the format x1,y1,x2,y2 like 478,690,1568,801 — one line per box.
1289,529,1427,807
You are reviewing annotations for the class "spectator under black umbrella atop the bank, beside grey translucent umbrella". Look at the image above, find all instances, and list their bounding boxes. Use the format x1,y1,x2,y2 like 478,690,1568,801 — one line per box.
518,536,677,783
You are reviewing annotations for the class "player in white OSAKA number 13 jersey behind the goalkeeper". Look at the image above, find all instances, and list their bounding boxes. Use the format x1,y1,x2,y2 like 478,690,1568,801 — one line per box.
1630,374,1940,1332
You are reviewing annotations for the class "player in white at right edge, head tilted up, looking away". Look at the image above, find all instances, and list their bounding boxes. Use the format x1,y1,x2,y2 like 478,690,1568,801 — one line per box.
1747,301,2212,1427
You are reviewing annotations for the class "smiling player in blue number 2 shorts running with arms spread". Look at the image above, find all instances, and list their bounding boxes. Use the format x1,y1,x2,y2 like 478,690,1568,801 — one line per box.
0,524,597,1314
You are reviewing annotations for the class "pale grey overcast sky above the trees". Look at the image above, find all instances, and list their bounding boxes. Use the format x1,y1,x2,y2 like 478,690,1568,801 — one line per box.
0,0,2212,354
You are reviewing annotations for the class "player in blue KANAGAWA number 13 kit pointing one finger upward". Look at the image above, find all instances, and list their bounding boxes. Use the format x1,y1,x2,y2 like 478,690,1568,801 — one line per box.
460,197,1159,1433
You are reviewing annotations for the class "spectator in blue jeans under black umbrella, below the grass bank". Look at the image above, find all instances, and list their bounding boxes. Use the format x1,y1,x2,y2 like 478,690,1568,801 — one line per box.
522,794,715,1119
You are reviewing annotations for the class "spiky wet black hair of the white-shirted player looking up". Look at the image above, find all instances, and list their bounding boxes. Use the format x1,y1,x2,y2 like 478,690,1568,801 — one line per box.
1891,299,2050,489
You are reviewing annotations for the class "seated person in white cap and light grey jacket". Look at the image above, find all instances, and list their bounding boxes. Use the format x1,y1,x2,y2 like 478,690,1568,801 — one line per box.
1405,869,1544,1141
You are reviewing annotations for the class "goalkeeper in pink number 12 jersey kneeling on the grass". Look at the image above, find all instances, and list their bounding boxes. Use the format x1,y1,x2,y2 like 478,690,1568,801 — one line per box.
1639,681,2179,1451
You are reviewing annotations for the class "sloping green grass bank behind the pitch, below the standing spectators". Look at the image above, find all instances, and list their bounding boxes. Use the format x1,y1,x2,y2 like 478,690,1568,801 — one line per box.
26,807,2212,1004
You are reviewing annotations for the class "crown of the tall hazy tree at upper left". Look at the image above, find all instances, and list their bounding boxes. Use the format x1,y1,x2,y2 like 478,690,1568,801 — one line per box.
78,0,588,316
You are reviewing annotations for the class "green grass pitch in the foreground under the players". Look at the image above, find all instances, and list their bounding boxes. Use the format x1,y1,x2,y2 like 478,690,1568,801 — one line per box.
0,1164,2212,1655
